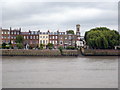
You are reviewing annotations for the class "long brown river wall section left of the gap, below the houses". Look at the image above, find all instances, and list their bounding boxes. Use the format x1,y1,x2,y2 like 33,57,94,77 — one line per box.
2,49,78,56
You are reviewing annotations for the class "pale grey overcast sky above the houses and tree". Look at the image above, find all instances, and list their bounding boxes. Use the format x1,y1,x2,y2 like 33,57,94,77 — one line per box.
2,2,118,35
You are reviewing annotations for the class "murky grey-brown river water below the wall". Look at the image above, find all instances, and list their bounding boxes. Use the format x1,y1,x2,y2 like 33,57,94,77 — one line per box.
2,56,118,88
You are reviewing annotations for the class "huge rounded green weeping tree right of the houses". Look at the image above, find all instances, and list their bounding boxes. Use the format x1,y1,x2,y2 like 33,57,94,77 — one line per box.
84,27,120,49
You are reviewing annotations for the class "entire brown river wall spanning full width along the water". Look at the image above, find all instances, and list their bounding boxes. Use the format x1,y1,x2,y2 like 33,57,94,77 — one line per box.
0,49,120,57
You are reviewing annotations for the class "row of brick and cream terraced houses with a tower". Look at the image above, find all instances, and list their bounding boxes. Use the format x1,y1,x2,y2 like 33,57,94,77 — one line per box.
1,24,83,48
